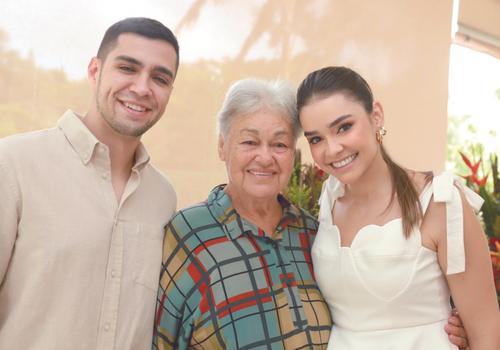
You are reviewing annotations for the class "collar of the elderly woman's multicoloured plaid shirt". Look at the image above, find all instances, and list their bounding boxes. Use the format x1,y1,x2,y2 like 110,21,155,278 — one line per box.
207,185,300,240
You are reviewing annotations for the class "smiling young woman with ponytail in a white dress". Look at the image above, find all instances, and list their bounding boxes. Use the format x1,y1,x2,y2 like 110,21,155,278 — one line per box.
297,67,500,350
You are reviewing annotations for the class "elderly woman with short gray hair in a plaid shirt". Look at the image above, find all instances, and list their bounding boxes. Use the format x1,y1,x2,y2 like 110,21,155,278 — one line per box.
153,80,331,349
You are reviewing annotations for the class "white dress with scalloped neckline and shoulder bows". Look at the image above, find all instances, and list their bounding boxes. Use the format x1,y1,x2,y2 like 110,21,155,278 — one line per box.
312,173,482,350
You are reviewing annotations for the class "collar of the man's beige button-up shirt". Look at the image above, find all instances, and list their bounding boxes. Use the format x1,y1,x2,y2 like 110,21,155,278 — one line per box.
57,110,150,170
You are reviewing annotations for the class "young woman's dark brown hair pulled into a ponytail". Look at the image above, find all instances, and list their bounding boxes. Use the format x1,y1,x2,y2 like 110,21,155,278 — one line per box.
297,67,423,237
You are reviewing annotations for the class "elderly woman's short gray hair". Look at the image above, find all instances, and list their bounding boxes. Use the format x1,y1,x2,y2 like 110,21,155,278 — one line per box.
217,79,301,140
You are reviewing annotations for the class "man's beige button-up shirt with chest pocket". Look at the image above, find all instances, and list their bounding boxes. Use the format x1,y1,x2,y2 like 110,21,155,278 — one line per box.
0,111,176,350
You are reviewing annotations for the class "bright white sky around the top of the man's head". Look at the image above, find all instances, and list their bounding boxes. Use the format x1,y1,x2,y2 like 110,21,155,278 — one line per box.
0,0,263,79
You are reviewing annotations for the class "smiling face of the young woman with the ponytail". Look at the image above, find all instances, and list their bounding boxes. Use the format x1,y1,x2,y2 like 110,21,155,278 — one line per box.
300,93,383,184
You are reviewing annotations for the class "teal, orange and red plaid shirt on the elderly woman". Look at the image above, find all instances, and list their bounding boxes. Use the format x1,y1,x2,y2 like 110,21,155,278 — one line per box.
153,186,332,349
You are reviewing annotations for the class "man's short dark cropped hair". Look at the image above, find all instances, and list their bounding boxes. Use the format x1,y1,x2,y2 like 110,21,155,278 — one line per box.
97,17,179,69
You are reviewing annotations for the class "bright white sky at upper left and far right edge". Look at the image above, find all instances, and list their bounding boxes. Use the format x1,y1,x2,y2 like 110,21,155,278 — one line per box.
0,0,500,152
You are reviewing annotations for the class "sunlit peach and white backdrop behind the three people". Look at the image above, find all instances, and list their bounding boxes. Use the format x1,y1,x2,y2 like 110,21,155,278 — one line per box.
0,0,500,206
